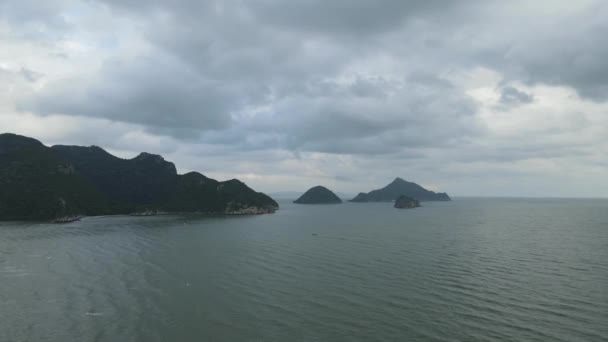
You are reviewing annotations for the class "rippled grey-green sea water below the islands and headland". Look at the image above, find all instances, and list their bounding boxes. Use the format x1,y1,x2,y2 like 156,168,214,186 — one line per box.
0,198,608,342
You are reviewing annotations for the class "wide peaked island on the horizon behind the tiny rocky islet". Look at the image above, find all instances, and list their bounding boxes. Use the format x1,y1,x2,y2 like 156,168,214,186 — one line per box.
350,177,451,202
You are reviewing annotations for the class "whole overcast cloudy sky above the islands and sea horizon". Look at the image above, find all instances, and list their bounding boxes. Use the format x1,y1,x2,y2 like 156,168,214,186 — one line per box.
0,0,608,197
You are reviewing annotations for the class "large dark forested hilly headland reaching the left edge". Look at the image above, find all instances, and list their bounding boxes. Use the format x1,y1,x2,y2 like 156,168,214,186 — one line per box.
0,133,279,222
